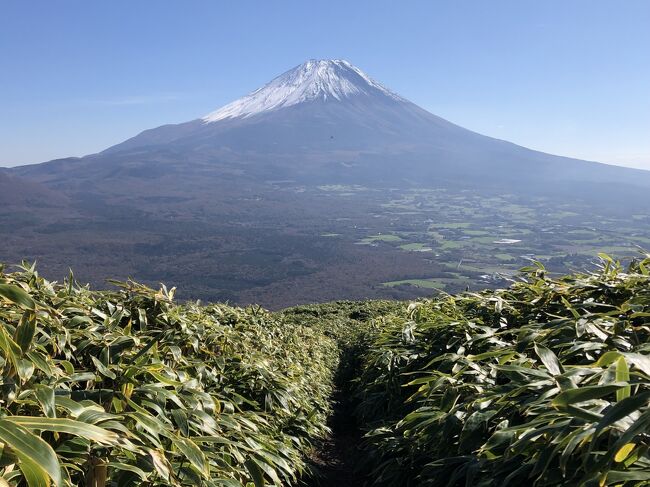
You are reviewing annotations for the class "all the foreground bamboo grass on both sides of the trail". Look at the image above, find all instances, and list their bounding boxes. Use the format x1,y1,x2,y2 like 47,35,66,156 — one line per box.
0,255,650,486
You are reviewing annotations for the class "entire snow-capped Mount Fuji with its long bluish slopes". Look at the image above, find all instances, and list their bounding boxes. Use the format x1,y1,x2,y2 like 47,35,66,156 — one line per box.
13,60,650,196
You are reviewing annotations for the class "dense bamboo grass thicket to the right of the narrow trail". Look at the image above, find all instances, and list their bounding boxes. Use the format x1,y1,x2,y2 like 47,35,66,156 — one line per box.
356,255,650,487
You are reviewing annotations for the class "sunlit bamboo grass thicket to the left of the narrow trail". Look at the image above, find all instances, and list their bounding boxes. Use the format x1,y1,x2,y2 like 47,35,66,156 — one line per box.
0,266,338,487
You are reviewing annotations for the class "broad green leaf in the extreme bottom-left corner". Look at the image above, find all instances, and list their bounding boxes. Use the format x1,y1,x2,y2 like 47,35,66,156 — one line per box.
0,418,62,486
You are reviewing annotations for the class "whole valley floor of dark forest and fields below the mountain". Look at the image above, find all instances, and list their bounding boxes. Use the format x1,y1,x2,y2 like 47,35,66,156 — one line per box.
0,182,650,310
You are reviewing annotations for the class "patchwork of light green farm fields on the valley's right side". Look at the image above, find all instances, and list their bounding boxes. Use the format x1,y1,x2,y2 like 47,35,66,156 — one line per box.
312,187,650,292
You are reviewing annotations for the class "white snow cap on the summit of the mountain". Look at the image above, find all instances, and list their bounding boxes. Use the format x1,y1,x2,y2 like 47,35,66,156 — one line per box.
202,59,403,123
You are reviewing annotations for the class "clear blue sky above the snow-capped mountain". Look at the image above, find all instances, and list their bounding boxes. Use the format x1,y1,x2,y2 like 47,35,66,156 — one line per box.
0,0,650,169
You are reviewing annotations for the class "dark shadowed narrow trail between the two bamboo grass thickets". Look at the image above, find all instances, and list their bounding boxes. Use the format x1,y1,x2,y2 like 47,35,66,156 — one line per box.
309,390,366,487
